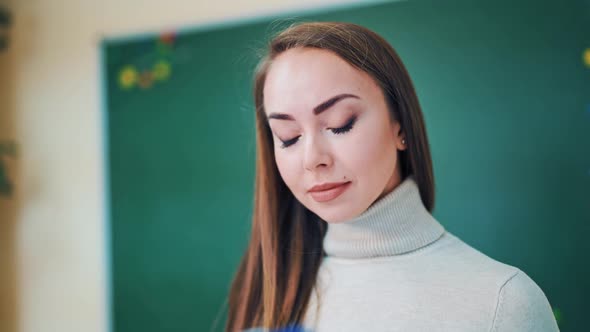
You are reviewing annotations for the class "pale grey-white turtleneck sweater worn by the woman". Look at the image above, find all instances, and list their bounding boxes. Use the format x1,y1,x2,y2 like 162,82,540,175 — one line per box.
304,177,559,332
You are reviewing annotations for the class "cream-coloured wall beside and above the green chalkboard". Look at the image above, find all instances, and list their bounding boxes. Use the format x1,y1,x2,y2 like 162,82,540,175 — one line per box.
0,0,380,332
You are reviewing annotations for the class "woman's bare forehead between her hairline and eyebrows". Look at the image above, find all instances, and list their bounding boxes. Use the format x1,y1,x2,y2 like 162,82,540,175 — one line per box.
264,48,378,113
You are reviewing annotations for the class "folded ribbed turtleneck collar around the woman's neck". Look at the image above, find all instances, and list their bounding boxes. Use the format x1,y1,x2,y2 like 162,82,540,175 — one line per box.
323,175,445,258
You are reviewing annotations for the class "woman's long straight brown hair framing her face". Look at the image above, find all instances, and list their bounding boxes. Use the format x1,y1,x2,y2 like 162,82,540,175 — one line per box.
226,22,434,332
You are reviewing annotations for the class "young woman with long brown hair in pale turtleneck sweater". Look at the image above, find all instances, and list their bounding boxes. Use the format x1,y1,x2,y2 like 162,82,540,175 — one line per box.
226,23,558,332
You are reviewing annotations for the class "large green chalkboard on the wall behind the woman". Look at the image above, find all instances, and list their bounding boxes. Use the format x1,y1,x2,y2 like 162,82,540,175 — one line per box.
101,0,590,332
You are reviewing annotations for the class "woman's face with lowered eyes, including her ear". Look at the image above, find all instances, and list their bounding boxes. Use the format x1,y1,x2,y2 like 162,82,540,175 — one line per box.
264,48,405,223
